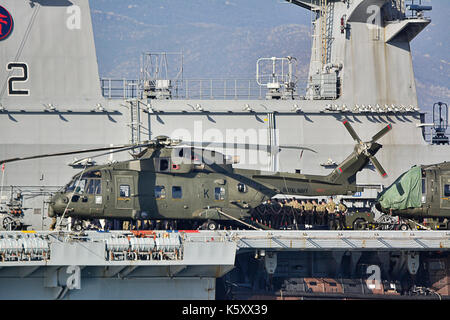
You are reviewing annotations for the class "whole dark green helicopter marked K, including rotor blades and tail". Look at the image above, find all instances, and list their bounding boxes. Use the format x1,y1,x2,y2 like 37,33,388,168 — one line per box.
0,120,392,230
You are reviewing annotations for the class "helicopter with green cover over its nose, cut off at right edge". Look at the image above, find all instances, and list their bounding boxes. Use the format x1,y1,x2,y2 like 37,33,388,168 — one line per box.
375,162,450,230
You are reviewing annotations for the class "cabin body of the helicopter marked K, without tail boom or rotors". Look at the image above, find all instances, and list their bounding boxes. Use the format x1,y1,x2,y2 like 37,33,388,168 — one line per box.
49,159,276,220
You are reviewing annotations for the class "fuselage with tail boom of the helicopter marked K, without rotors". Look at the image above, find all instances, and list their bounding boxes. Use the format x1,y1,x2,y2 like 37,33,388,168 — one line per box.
49,158,357,220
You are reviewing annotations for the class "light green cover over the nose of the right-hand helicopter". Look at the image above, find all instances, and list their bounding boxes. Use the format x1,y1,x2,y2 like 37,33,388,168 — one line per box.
378,167,422,210
